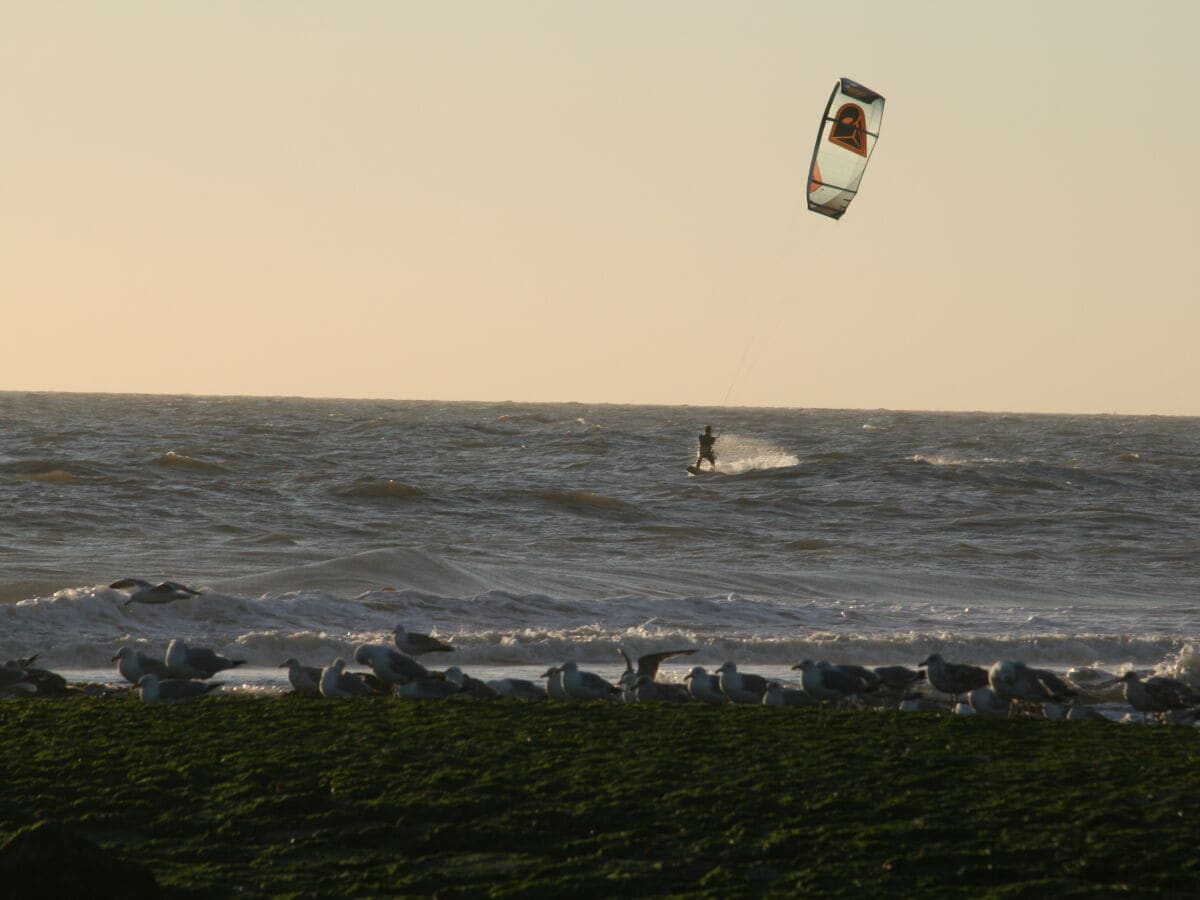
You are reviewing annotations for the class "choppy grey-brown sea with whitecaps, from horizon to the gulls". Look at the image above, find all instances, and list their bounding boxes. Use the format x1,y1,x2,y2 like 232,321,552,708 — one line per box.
0,392,1200,686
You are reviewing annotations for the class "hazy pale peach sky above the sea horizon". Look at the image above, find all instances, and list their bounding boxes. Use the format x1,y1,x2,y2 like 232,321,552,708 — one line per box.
0,0,1200,414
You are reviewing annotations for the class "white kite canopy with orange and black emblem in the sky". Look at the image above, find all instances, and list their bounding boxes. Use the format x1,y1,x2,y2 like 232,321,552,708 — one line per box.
809,78,883,218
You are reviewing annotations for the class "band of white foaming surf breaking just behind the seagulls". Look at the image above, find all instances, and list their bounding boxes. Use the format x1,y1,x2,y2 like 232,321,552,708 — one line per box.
0,586,1189,667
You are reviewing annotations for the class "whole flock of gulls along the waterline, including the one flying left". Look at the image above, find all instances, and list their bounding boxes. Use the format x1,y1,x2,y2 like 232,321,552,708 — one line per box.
7,578,1200,724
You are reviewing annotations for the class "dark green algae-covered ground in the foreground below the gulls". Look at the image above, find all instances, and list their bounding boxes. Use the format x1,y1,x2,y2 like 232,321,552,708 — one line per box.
0,697,1200,898
